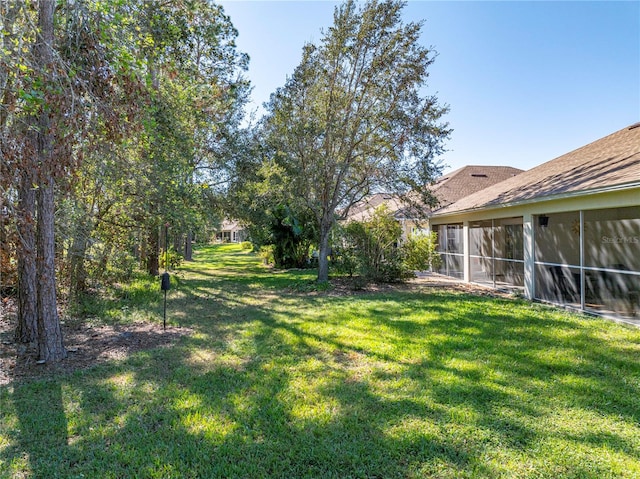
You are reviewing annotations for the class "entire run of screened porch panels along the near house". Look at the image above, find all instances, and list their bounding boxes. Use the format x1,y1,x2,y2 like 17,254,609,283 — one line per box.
434,206,640,322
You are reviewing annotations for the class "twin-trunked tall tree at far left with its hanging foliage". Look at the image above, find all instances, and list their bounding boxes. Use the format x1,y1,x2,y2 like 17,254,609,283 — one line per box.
0,0,144,361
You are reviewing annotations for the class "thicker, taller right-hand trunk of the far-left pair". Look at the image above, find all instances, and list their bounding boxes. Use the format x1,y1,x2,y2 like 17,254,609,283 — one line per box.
34,0,67,362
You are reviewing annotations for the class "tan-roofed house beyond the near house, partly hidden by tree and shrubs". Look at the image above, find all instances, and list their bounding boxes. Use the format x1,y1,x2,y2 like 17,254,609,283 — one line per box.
346,166,523,239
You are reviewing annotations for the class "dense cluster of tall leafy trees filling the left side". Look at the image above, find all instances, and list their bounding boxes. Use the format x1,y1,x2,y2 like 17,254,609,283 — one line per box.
0,0,249,361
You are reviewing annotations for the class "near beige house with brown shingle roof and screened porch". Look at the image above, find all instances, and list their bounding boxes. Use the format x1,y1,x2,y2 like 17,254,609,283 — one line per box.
430,123,640,322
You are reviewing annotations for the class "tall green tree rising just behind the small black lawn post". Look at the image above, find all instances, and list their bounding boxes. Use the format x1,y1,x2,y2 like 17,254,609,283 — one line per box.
131,0,248,275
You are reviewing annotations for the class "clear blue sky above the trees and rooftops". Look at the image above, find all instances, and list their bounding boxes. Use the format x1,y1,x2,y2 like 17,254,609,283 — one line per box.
219,0,640,172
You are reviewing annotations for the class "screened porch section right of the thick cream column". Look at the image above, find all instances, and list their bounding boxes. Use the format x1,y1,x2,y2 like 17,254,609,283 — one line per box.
535,206,640,317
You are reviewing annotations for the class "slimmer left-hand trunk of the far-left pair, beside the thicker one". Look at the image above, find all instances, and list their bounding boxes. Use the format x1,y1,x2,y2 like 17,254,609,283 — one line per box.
15,174,38,343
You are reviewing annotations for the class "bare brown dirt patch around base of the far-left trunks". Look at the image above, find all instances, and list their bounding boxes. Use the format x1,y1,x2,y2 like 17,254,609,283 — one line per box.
0,301,192,386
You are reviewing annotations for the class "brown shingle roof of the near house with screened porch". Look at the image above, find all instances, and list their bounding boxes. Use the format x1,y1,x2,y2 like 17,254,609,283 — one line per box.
436,123,640,215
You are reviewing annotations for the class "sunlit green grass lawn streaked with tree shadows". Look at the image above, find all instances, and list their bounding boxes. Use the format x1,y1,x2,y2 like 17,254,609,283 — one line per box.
0,245,640,479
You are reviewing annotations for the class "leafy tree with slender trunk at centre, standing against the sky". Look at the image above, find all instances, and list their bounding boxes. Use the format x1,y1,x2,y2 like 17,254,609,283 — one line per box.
265,0,450,281
